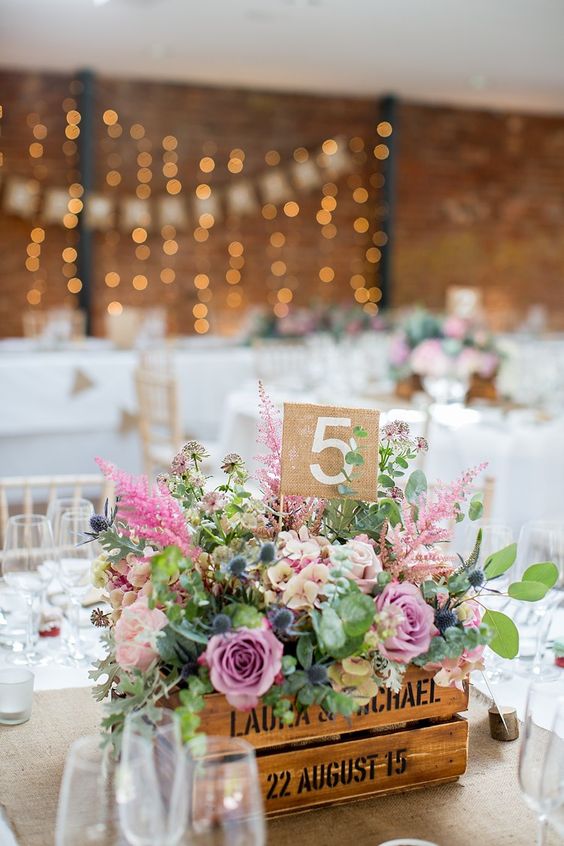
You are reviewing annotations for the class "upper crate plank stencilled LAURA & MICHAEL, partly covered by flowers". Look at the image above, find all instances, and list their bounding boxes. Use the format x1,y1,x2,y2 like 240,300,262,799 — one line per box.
196,667,468,749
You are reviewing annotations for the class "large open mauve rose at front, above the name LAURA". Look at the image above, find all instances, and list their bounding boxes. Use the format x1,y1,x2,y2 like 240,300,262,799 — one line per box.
200,628,284,711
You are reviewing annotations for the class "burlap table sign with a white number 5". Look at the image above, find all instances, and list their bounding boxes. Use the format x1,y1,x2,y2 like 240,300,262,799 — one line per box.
280,403,380,502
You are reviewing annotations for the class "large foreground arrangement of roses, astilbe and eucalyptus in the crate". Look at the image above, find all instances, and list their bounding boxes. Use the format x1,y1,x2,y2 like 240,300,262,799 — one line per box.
90,388,557,738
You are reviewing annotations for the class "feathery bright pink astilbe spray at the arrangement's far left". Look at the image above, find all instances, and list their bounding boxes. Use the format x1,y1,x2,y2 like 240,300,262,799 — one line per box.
96,458,199,559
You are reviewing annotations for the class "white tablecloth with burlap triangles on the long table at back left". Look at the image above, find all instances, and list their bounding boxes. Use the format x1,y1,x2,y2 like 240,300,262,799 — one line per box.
0,345,253,476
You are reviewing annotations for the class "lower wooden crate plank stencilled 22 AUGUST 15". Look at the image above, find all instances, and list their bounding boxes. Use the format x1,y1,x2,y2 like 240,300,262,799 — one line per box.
257,718,468,816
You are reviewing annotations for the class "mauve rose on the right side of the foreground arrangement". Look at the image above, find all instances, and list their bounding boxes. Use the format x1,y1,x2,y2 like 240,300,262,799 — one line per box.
376,582,435,664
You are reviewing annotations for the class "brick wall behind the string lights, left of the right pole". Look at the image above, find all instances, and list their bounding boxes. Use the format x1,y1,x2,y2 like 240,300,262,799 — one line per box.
0,73,379,334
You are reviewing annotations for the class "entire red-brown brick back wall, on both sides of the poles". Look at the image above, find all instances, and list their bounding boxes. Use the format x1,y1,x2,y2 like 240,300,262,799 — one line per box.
0,71,564,335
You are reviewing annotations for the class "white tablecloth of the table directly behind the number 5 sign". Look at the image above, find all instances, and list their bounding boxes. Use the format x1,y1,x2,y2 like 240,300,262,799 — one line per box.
220,390,564,532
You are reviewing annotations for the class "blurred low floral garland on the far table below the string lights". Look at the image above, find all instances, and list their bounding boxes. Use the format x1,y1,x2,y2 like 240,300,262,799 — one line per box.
248,303,387,341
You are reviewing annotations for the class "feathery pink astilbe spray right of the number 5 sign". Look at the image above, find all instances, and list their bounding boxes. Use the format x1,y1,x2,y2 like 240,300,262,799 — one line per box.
388,464,487,582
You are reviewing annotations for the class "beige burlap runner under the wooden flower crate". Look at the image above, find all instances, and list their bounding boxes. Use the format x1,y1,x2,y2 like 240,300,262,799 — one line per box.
0,689,558,846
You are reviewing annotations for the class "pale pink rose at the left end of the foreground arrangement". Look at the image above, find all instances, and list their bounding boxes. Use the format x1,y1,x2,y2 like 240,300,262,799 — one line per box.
114,597,168,672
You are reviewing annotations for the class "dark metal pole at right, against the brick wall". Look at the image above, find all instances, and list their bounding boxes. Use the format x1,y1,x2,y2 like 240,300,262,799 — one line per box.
378,96,398,308
